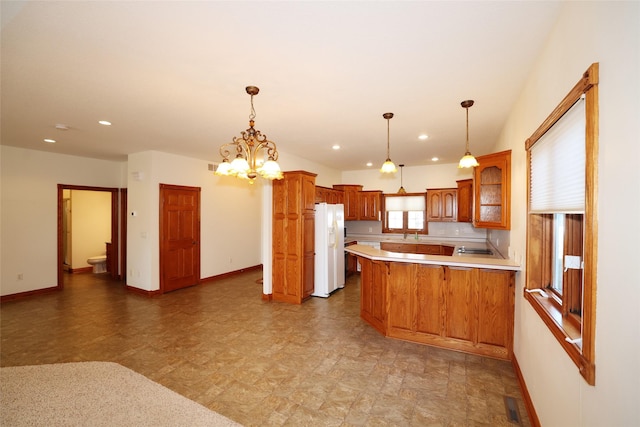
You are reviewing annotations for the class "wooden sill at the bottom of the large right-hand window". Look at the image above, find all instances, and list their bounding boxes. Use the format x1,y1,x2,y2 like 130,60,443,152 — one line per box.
524,289,595,385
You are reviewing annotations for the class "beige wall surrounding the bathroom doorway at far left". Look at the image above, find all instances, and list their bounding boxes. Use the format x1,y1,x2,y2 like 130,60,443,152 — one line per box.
0,145,124,295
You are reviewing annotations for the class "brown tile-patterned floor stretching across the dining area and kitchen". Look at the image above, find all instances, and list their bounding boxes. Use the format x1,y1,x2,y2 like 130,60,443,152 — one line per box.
0,272,529,426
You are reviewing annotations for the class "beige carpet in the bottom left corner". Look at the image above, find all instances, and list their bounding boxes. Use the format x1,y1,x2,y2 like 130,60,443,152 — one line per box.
0,362,240,426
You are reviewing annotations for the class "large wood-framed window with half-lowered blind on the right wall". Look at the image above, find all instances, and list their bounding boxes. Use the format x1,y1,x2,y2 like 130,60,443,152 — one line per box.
524,63,599,385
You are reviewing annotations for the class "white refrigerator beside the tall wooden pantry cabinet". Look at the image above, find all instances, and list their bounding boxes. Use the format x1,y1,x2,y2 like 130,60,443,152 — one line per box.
311,203,344,298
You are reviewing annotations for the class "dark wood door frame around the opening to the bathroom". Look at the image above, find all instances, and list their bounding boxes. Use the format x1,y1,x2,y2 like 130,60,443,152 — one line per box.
57,184,127,289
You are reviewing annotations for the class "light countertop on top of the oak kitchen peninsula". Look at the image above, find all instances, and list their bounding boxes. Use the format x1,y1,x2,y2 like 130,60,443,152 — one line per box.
344,244,522,271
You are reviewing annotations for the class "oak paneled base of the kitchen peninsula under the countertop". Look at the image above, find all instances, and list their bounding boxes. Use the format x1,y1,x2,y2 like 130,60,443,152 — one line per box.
370,260,515,360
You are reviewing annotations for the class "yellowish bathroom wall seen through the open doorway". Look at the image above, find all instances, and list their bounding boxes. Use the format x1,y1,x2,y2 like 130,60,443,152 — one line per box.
71,190,111,268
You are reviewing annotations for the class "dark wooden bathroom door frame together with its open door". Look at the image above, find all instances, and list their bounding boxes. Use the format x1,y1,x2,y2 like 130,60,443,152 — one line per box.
57,184,127,289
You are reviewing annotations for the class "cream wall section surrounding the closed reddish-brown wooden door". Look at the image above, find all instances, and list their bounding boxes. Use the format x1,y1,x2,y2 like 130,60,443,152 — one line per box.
127,151,262,291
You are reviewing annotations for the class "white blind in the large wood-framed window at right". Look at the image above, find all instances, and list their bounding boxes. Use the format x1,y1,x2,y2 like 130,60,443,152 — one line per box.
530,98,586,213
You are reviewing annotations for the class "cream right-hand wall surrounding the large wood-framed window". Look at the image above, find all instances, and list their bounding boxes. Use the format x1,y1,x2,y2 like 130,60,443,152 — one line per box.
492,2,640,427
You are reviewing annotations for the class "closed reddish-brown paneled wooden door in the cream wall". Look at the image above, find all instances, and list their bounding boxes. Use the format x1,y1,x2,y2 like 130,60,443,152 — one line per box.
160,184,200,293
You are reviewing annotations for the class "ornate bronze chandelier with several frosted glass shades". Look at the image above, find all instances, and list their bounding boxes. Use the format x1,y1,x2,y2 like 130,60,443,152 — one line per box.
215,86,282,184
